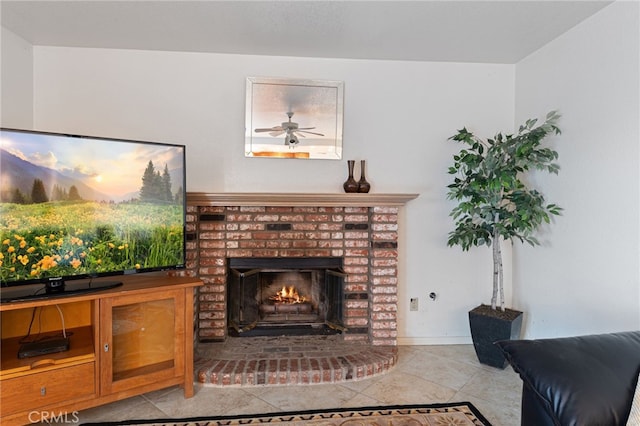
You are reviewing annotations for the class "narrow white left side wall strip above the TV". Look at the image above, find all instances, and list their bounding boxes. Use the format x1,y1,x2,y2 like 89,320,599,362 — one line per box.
0,28,33,128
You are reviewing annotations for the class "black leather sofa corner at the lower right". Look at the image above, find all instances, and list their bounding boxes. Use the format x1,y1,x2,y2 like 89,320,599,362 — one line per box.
496,331,640,426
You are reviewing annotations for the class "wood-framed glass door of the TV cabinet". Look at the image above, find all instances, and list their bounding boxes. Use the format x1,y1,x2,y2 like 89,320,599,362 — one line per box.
101,290,184,393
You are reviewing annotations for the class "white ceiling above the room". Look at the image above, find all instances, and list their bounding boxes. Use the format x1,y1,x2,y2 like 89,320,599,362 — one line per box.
0,0,611,64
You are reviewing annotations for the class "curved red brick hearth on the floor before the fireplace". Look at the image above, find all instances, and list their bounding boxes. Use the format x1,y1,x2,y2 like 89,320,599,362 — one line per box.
194,335,398,387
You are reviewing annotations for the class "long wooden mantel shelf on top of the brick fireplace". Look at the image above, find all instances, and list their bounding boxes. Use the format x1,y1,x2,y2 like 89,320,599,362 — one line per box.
187,192,419,207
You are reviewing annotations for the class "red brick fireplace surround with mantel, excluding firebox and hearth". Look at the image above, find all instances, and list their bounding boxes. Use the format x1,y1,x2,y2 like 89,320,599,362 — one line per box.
182,193,416,346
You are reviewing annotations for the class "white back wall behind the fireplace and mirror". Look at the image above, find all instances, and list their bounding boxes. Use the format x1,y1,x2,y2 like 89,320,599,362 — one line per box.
28,47,515,343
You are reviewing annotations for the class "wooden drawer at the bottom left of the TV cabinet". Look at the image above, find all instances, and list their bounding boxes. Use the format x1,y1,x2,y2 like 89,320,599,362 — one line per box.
0,362,96,416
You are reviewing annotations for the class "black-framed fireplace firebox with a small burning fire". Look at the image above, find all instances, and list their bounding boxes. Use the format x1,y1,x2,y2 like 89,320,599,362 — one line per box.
227,257,346,336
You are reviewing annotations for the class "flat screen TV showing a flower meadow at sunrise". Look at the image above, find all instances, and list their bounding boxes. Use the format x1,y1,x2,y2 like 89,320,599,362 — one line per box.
0,129,186,302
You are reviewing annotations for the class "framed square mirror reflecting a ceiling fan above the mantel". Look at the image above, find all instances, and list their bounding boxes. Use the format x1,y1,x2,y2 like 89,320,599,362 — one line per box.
245,77,344,160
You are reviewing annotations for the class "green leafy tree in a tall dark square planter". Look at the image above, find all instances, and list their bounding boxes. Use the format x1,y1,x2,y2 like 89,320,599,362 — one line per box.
447,111,562,368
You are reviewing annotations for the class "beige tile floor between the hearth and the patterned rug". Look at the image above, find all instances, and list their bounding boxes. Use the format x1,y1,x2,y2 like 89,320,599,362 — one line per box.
79,345,522,426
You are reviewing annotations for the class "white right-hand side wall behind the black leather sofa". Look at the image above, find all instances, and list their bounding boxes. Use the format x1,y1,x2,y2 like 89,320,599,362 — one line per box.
513,1,640,337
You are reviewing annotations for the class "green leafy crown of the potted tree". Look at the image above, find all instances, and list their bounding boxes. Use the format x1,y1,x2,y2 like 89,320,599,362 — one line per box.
447,111,562,255
